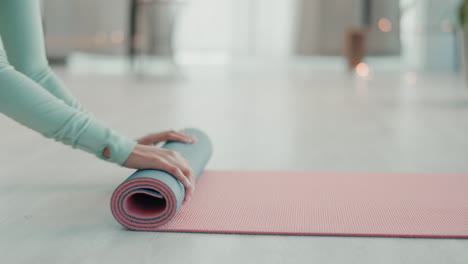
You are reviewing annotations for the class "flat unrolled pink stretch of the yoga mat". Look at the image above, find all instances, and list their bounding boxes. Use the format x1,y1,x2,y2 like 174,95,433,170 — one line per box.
147,171,468,238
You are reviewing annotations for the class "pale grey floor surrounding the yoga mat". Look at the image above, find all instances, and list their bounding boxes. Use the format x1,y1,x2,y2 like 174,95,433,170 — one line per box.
0,58,468,264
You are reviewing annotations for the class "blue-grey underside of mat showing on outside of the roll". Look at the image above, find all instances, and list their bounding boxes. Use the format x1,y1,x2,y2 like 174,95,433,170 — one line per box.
126,128,213,210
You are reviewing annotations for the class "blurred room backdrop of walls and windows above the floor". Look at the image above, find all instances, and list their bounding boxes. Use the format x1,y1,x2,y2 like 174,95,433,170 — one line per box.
42,0,468,74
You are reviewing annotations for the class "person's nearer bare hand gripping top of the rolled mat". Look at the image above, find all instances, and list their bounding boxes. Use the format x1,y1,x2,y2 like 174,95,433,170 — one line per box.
124,144,195,203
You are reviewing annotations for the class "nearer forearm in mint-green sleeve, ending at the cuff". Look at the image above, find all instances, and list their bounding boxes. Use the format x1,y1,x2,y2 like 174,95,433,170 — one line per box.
0,64,136,165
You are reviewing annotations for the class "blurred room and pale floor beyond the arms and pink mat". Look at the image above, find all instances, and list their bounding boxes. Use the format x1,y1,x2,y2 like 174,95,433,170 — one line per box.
26,0,468,172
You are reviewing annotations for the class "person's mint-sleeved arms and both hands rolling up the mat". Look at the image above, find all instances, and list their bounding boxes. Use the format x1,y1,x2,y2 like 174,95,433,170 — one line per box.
0,0,195,202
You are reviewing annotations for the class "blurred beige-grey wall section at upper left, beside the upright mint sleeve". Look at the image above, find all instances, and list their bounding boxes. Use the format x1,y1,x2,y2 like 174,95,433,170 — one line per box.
42,0,129,58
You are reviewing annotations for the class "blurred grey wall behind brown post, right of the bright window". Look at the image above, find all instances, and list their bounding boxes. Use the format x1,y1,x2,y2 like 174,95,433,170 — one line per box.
296,0,400,55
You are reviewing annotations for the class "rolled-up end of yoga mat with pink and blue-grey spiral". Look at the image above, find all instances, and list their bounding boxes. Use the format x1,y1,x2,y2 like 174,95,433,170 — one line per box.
111,129,212,230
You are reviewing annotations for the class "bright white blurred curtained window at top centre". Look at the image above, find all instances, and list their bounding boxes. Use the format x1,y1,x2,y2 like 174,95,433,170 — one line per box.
176,0,296,57
